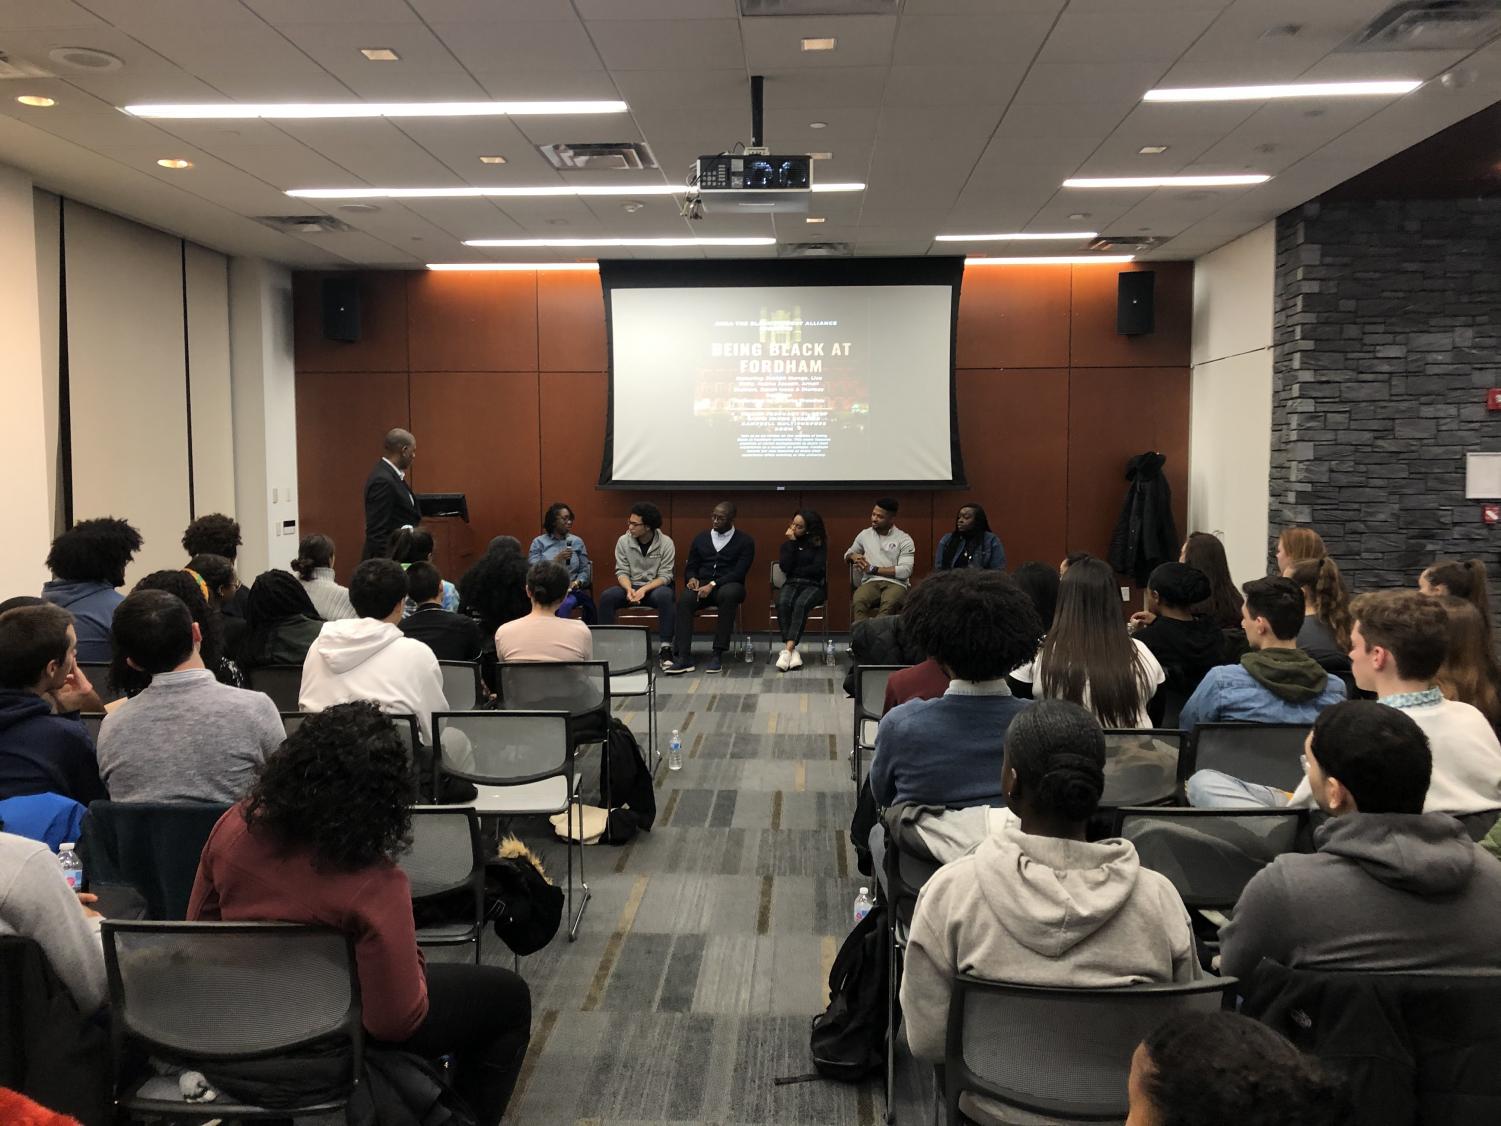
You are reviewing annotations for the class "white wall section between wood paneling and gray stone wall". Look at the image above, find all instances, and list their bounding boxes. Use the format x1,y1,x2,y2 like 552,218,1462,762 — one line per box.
1189,224,1276,583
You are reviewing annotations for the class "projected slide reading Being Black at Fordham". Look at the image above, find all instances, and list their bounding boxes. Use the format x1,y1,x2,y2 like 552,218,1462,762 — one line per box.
609,285,953,485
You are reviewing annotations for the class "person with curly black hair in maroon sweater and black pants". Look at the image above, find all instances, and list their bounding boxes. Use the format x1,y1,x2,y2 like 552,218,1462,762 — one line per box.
188,705,531,1126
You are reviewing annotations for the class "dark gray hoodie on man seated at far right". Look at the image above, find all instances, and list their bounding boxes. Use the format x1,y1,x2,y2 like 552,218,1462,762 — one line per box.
1220,814,1501,979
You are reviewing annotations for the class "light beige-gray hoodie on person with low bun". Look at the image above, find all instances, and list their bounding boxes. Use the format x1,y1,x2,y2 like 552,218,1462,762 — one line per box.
902,817,1200,1061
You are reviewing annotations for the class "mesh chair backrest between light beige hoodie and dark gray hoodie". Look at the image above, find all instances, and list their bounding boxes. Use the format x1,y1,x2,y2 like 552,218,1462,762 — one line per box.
1117,806,1309,910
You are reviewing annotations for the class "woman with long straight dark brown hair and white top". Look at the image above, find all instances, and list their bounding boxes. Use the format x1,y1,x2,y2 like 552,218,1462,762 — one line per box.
1012,557,1166,728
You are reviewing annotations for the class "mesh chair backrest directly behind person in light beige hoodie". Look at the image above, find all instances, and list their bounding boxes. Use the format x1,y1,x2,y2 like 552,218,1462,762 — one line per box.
944,974,1235,1123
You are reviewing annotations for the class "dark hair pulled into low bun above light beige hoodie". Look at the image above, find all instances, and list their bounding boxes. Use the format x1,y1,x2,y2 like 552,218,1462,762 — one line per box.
1003,700,1105,824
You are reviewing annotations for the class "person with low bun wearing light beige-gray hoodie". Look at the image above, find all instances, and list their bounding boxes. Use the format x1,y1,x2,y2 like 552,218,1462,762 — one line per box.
901,700,1200,1080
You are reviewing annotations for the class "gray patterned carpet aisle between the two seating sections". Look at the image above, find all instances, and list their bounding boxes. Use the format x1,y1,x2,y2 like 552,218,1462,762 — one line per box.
438,651,906,1126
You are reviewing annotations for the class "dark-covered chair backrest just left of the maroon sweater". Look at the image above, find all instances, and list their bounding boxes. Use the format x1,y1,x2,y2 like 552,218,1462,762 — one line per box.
81,800,230,919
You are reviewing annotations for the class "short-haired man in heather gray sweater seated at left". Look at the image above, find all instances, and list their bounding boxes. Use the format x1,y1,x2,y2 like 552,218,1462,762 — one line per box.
99,591,285,802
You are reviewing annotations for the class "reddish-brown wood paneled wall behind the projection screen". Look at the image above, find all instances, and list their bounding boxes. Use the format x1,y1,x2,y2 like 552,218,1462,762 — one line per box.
296,263,1193,629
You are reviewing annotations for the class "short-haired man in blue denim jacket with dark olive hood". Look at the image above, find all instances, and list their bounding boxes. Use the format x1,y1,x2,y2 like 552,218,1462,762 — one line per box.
1178,578,1345,753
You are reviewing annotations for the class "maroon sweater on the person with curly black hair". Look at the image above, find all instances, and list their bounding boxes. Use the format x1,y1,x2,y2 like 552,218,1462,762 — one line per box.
188,806,428,1042
